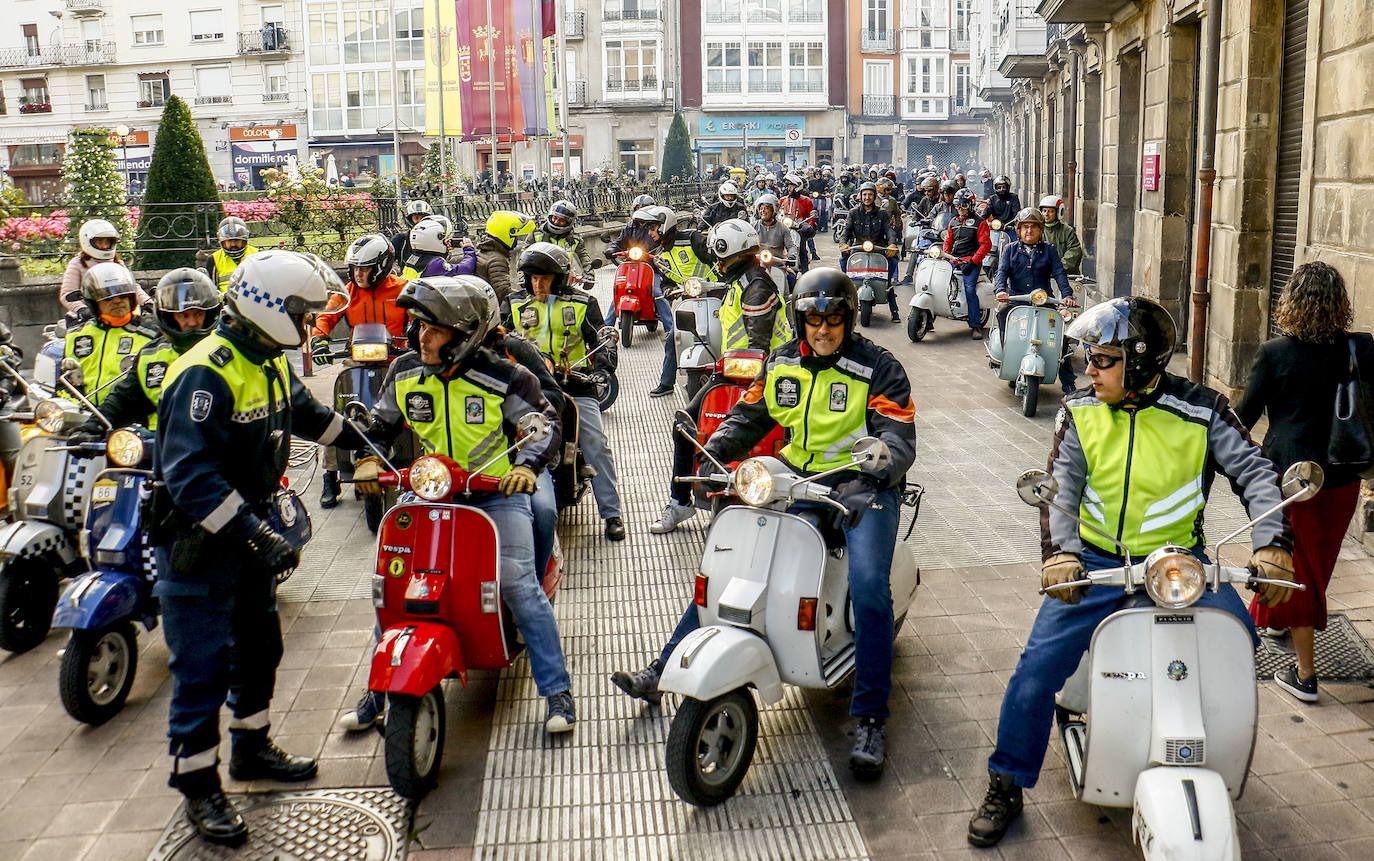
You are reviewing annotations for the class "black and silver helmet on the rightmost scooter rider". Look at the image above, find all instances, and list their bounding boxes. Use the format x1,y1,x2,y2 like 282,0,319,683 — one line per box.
1060,292,1178,402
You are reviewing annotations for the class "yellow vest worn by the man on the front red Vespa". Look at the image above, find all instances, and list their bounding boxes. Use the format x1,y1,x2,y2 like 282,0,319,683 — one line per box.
396,368,511,478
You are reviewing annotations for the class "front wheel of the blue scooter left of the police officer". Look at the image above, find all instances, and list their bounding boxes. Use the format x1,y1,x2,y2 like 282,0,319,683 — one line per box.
58,622,139,726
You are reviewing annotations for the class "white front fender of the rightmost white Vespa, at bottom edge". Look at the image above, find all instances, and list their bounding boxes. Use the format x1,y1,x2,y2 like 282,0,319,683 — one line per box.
1131,765,1241,861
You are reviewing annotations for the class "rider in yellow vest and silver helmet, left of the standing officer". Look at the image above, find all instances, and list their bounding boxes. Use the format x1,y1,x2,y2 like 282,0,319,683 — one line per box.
63,261,157,405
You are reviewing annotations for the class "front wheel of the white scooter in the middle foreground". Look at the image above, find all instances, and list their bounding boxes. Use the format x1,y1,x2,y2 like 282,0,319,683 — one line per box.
666,688,758,807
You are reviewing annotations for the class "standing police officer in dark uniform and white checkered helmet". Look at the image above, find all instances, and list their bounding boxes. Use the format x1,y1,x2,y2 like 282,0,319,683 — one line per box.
153,251,363,845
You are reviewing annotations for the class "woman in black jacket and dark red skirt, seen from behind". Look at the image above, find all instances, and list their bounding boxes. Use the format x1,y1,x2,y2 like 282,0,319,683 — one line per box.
1235,262,1374,703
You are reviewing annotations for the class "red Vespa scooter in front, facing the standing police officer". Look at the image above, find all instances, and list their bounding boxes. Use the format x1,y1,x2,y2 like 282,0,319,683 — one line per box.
351,413,563,801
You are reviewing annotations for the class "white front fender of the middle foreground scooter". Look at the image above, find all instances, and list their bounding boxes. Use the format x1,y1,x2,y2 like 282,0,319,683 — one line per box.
658,625,782,703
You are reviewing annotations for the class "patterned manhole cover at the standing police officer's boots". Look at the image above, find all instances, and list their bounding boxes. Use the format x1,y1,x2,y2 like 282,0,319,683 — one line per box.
148,790,411,861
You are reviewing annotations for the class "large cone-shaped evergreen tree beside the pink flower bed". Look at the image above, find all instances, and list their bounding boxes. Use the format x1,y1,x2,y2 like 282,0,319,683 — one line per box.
137,96,224,269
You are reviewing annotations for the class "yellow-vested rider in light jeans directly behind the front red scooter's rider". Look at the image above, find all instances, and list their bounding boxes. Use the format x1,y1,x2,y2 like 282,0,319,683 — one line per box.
510,242,625,541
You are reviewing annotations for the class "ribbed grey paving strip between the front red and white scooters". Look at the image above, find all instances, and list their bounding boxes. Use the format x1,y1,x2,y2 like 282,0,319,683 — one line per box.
474,274,867,861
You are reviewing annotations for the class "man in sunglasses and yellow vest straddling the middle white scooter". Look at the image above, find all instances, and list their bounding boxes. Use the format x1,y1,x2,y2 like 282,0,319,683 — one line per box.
611,268,915,780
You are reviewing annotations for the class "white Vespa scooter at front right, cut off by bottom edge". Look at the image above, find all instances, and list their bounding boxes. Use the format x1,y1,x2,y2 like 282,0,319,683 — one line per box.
1017,463,1323,861
